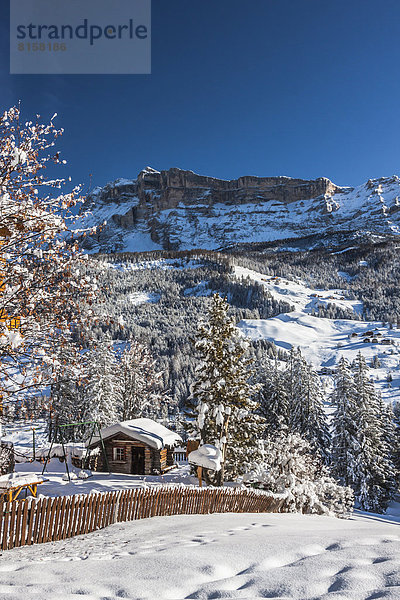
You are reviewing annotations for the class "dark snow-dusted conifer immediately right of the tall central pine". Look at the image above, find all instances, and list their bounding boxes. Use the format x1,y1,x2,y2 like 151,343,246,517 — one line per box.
256,357,290,434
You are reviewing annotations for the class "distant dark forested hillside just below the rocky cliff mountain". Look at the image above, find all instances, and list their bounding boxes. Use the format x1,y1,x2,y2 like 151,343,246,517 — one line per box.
84,240,400,407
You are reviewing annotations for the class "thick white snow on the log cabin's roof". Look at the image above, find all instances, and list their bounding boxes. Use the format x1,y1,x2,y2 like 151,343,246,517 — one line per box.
90,419,182,450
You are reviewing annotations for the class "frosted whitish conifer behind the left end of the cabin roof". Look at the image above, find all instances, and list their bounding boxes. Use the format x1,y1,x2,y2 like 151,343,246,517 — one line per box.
84,341,121,427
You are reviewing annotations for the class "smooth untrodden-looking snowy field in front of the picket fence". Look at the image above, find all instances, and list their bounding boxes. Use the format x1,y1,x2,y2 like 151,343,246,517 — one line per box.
0,514,400,600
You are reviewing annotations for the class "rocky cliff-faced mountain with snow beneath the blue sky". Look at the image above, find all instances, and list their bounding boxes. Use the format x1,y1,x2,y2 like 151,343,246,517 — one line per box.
79,167,400,252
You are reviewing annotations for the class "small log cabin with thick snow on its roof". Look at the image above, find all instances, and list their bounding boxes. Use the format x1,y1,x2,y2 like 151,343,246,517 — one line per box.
88,418,182,475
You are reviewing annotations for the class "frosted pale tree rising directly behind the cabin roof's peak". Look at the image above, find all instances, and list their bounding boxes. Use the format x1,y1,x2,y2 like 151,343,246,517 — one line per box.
117,340,161,421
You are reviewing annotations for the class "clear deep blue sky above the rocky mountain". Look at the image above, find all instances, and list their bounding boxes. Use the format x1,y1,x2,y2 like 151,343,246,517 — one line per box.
0,0,400,186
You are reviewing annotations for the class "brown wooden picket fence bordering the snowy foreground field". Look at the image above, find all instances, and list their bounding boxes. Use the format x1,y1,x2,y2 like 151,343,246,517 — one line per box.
0,486,285,550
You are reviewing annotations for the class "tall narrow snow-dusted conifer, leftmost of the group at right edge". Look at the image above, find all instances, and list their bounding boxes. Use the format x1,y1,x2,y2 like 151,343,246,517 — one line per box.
331,357,359,488
